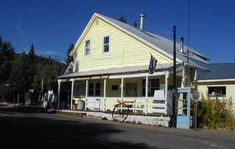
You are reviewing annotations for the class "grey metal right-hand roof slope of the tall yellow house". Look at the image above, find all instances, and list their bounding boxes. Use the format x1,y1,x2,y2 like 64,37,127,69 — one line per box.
95,14,209,69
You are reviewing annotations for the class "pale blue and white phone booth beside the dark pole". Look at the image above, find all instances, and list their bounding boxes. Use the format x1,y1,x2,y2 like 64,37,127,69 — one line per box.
176,87,192,129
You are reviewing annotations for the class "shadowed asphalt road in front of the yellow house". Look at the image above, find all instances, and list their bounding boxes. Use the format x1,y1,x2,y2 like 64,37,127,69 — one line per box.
0,106,235,149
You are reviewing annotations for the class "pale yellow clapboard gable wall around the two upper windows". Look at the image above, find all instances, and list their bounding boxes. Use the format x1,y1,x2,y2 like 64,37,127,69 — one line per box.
75,18,171,71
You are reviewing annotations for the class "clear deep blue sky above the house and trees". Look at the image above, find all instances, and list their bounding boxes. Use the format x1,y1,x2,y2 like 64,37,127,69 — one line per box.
0,0,235,63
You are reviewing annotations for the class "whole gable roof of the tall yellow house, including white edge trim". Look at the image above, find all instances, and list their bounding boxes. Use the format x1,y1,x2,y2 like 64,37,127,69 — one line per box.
70,13,209,69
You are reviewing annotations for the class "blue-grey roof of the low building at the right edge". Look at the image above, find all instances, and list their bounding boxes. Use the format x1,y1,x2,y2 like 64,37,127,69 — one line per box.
197,63,235,80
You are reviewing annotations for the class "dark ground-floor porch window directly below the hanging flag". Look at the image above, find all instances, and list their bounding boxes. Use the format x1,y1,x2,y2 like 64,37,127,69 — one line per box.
142,79,160,97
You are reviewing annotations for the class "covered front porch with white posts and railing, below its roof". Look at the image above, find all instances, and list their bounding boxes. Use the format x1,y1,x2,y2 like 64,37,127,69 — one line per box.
58,71,178,116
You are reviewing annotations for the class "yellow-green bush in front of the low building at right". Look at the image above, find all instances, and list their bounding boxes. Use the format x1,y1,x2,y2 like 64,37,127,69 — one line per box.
198,97,235,129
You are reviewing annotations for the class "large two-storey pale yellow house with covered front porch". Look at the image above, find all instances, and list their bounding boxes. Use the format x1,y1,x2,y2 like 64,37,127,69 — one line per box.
58,13,208,115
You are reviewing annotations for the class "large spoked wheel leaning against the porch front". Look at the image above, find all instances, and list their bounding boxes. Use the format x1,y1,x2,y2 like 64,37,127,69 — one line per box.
112,103,130,122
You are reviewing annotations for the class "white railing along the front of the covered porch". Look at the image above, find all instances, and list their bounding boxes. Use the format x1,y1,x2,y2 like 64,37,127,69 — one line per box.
86,97,171,115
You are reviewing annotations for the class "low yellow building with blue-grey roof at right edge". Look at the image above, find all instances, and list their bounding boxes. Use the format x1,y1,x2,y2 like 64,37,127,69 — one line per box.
197,63,235,109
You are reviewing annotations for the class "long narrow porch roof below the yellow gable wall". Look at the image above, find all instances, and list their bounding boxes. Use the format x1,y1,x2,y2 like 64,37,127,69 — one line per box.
58,64,178,79
